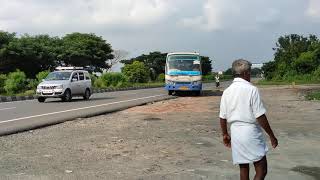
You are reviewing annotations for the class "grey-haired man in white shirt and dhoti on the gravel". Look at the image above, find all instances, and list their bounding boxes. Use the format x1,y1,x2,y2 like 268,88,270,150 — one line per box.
219,59,278,180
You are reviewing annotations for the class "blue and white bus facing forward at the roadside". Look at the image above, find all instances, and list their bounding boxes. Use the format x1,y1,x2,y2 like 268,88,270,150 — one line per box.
165,52,202,95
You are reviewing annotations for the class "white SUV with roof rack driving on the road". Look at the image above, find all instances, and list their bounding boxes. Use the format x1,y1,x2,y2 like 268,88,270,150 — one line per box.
37,67,92,102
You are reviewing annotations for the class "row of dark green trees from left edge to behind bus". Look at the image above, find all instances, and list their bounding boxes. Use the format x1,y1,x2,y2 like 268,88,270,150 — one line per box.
0,31,212,79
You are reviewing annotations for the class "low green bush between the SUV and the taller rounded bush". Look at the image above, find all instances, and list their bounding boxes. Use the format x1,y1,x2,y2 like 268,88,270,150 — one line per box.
100,73,127,87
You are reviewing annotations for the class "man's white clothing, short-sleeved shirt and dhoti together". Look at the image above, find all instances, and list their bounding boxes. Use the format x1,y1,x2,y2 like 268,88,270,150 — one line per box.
219,78,268,164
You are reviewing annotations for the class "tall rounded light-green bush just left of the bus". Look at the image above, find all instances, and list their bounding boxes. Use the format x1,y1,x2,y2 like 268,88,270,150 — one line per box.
122,61,150,83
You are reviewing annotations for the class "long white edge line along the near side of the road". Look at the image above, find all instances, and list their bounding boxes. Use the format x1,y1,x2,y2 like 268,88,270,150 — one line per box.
0,94,165,124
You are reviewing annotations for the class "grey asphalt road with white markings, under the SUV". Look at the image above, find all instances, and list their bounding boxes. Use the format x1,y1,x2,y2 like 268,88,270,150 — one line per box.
0,82,230,135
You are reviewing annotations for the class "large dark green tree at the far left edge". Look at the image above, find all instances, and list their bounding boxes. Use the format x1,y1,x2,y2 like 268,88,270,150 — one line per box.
0,34,60,78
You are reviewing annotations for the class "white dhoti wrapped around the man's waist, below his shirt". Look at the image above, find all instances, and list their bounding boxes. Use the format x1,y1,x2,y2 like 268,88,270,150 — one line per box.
230,122,268,164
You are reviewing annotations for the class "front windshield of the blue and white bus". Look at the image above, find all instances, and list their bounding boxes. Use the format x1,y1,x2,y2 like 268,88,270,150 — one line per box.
168,56,200,71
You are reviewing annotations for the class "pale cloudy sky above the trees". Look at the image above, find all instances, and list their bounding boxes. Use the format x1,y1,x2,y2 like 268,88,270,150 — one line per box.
0,0,320,71
